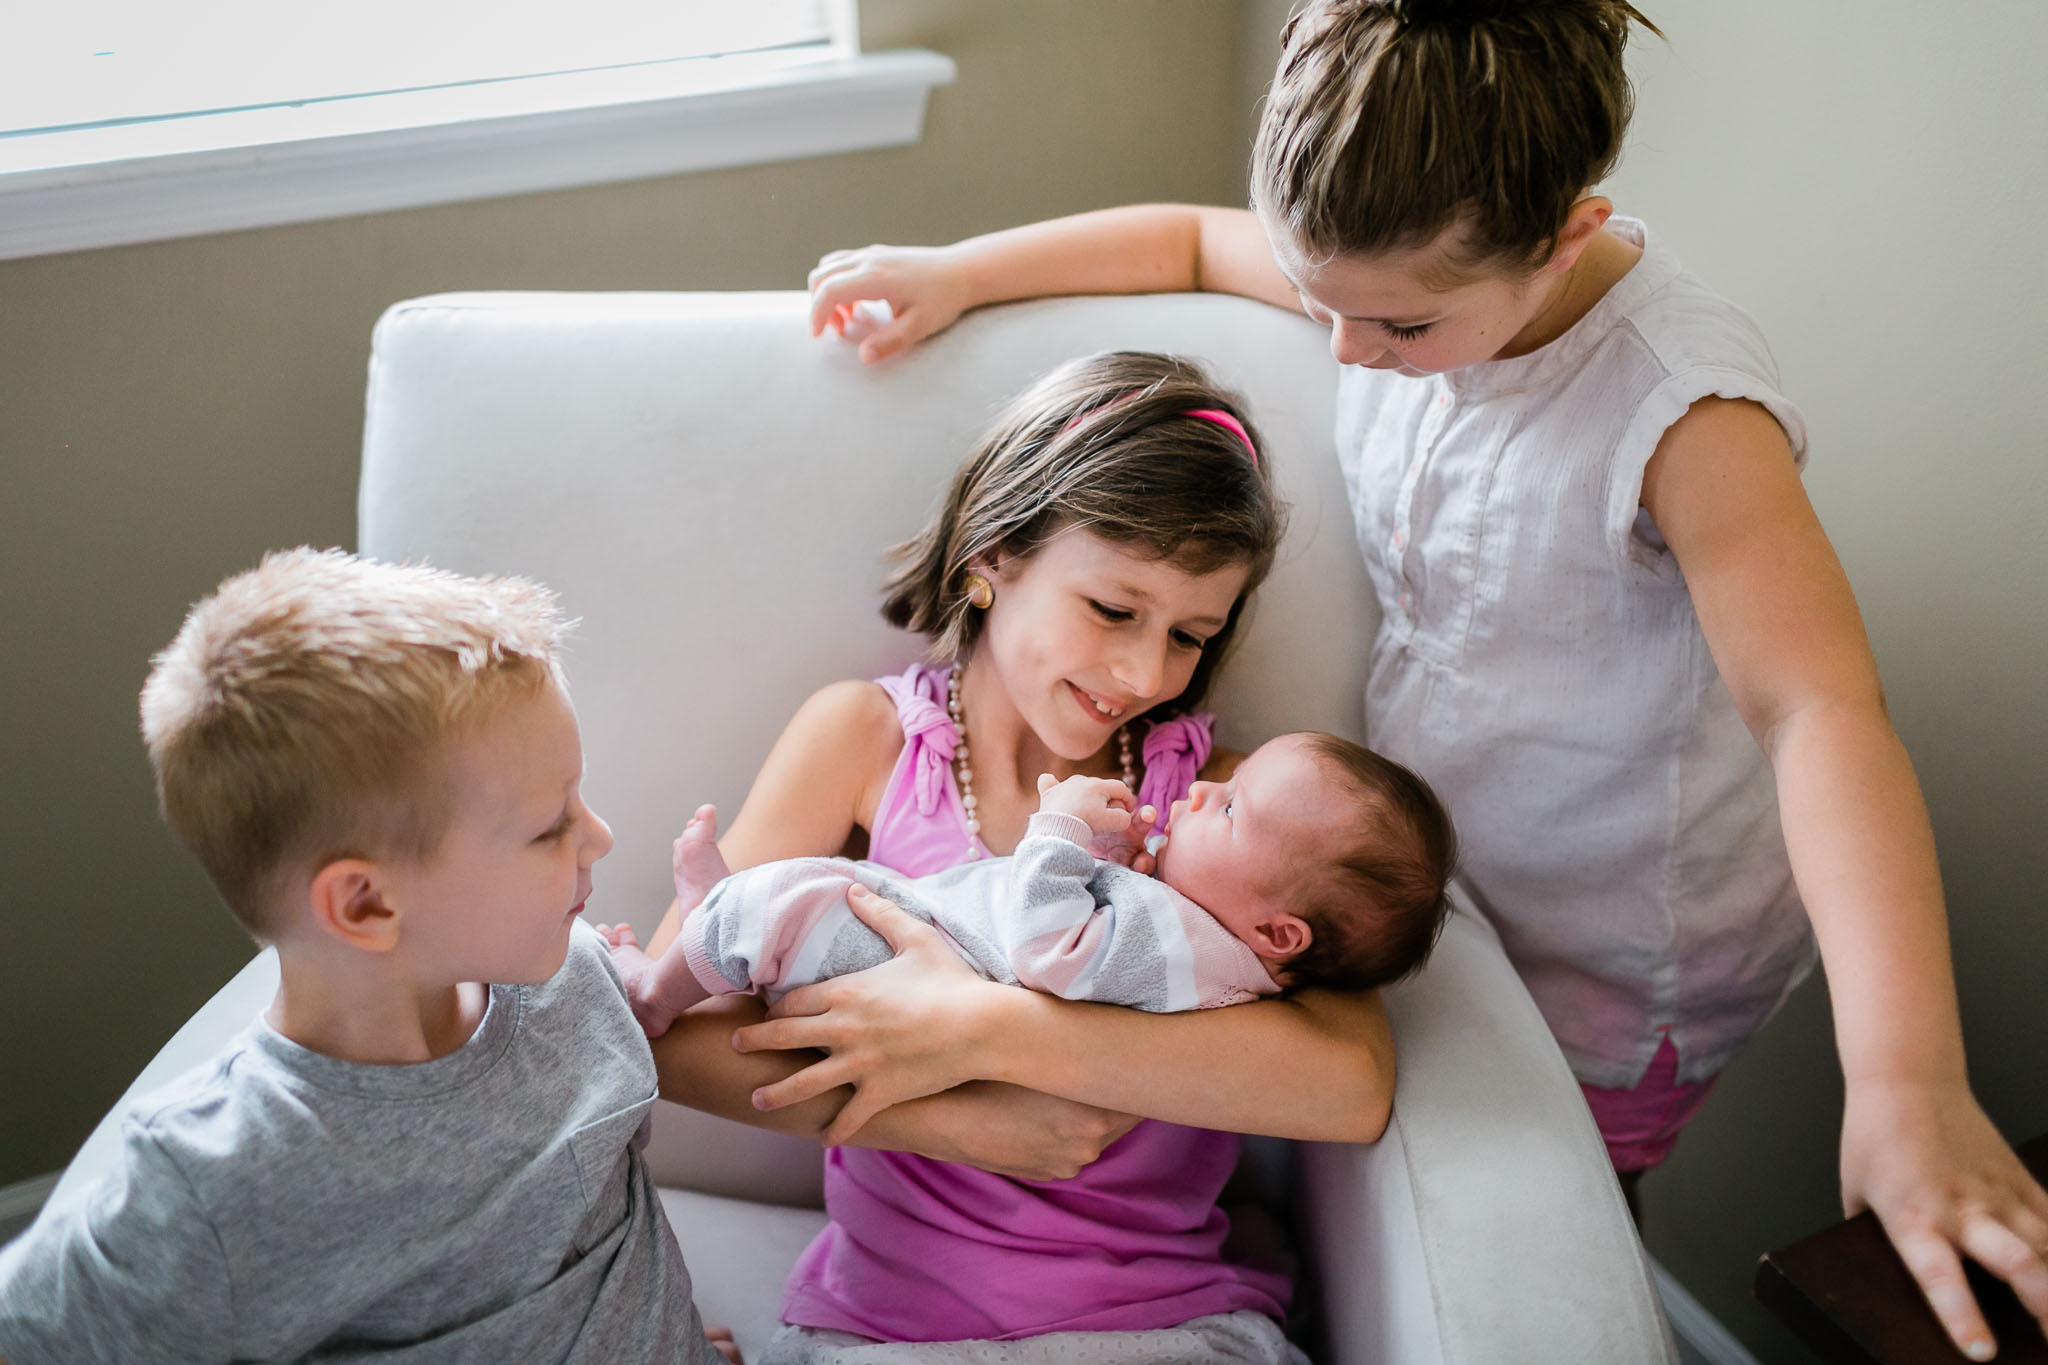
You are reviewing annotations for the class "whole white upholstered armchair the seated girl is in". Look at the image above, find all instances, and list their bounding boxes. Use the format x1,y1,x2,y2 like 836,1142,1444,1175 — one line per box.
55,293,1675,1365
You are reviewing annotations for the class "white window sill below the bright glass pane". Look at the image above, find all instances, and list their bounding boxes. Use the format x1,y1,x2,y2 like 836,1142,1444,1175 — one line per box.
0,49,954,260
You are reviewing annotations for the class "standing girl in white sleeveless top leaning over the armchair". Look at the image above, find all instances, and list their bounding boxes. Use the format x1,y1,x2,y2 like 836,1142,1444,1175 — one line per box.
794,0,2048,1359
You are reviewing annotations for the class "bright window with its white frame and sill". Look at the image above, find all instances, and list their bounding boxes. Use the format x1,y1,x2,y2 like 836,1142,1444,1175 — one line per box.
0,0,952,258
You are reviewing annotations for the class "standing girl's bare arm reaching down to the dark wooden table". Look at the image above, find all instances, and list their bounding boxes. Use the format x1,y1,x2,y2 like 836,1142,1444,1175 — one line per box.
1642,399,2048,1359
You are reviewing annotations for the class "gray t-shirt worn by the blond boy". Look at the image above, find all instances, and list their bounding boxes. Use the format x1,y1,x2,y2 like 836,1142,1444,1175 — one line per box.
0,925,721,1365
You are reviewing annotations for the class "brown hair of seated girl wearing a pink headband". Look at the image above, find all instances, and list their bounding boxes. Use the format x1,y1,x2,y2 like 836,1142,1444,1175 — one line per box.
883,350,1286,718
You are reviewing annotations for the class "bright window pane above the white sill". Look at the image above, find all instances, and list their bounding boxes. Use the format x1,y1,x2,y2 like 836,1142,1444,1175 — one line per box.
0,0,852,137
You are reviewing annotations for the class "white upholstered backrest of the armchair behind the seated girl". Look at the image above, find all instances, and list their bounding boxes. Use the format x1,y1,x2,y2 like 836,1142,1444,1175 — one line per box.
358,293,1374,949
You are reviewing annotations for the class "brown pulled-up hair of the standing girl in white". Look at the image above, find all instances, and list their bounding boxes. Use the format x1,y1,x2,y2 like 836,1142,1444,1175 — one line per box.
1251,0,1659,278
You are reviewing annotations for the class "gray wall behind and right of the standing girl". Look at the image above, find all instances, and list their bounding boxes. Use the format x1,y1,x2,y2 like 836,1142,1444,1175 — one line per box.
1612,0,2048,1361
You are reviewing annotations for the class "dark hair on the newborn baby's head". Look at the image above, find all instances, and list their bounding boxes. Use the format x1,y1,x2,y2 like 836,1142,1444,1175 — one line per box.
1282,735,1458,990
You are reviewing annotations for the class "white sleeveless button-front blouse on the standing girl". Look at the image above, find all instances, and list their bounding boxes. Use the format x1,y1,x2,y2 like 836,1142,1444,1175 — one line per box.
1337,219,1815,1087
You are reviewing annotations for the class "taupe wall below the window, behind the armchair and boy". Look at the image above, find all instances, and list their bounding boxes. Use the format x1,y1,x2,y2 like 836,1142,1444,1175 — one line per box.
0,0,1243,1185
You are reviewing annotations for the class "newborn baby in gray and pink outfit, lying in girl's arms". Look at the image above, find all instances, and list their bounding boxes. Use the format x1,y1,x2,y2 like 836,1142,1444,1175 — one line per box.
600,735,1456,1038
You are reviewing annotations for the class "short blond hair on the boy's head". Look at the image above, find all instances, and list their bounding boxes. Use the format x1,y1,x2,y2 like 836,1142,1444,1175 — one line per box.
141,546,567,941
